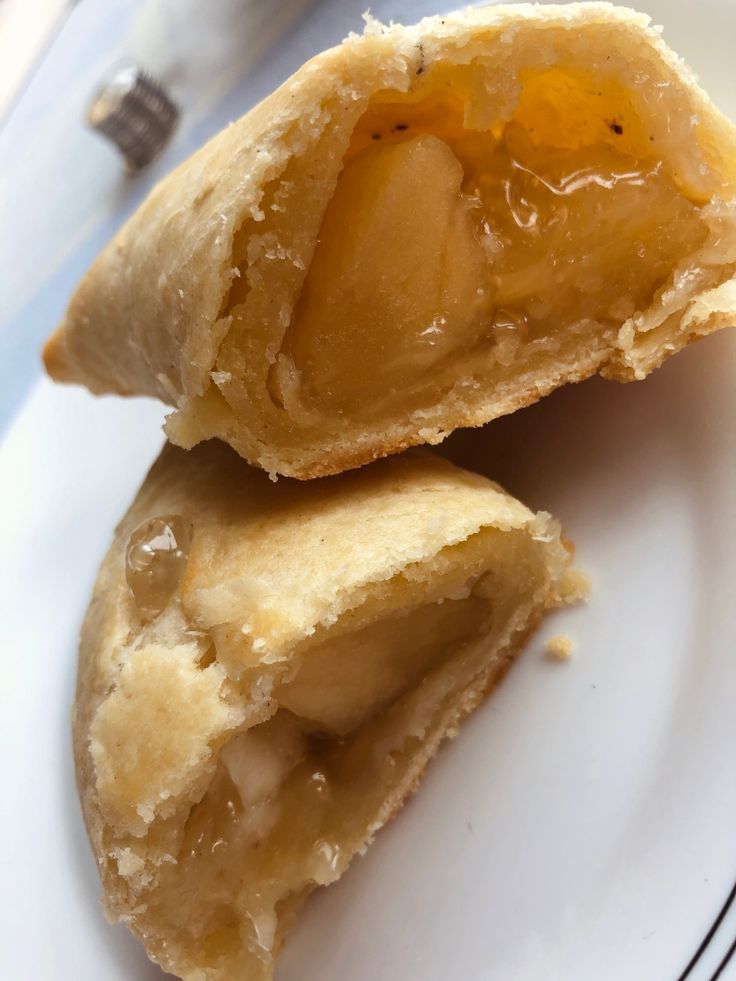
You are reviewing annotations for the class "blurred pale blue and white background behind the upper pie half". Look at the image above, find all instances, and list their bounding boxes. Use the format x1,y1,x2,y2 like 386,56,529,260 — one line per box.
0,0,736,436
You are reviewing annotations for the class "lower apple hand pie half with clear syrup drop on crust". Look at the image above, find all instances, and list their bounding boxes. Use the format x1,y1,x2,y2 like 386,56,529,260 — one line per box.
74,441,584,981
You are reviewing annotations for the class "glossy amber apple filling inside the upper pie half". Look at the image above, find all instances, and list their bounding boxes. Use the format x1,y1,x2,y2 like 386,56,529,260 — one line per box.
221,64,708,423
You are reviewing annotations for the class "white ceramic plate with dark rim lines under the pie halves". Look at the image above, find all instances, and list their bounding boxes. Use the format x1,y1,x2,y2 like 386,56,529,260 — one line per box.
0,3,736,981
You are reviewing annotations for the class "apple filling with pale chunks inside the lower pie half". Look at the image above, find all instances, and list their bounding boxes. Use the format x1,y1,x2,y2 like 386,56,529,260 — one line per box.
146,580,493,968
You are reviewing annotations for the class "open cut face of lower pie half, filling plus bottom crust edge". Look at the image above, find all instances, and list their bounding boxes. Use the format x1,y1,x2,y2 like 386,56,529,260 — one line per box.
142,531,552,978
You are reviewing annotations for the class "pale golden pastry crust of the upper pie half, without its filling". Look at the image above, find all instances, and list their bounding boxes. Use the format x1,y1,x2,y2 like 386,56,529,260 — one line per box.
44,3,736,479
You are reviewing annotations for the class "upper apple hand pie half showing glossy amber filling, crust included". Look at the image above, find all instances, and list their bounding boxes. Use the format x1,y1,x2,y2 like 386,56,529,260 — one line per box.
45,3,736,478
